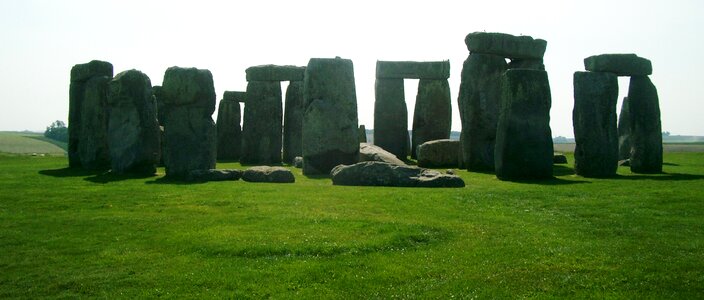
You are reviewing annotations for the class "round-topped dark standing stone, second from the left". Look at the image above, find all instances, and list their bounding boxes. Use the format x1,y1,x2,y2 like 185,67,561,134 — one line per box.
108,70,161,175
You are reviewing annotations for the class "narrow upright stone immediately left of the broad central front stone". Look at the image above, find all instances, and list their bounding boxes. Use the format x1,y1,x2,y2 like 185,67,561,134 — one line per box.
283,81,303,164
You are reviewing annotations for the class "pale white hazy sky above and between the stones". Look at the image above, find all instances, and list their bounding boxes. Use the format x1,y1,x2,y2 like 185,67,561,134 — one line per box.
0,0,704,137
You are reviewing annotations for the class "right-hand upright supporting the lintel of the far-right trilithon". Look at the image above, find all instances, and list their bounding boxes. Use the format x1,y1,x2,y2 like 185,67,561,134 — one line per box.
628,76,662,174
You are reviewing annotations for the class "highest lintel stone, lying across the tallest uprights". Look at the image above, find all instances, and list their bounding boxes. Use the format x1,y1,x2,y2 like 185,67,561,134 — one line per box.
464,32,548,59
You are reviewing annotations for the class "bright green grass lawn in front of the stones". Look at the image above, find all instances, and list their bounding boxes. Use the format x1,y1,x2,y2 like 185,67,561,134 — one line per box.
0,153,704,299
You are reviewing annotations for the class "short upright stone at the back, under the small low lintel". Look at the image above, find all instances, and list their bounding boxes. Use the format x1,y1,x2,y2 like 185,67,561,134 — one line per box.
216,97,242,160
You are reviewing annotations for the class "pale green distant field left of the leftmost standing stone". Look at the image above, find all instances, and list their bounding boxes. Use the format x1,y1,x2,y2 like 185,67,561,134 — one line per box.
0,132,67,155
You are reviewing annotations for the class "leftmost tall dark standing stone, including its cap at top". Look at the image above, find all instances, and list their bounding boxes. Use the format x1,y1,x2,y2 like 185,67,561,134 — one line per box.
68,60,113,169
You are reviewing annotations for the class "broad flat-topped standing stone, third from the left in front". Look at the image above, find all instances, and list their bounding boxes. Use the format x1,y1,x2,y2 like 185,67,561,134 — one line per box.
161,67,217,178
